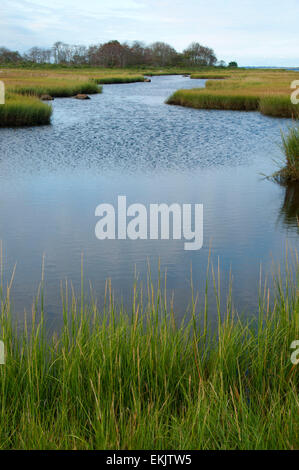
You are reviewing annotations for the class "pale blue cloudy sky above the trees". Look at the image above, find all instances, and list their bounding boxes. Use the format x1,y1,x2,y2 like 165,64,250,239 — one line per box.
0,0,299,66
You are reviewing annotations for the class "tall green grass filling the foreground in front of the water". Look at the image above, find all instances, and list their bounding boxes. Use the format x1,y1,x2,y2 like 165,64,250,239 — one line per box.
0,260,299,450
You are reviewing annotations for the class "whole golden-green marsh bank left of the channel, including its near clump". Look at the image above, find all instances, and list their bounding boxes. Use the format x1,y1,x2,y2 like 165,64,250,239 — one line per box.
0,67,157,127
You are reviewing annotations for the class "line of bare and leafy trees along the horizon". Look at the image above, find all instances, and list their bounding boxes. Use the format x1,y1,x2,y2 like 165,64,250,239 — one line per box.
0,41,239,68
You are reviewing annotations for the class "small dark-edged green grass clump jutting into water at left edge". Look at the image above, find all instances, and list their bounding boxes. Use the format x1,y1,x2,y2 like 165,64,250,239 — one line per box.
0,93,52,127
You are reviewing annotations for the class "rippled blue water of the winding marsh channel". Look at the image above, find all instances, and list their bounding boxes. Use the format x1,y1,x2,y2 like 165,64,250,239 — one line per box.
0,76,299,324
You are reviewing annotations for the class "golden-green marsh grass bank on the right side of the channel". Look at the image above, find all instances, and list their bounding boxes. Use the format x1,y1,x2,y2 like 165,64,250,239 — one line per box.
167,69,299,119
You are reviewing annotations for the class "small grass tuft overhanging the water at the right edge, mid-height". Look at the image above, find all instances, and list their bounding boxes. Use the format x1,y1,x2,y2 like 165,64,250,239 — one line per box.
273,126,299,183
